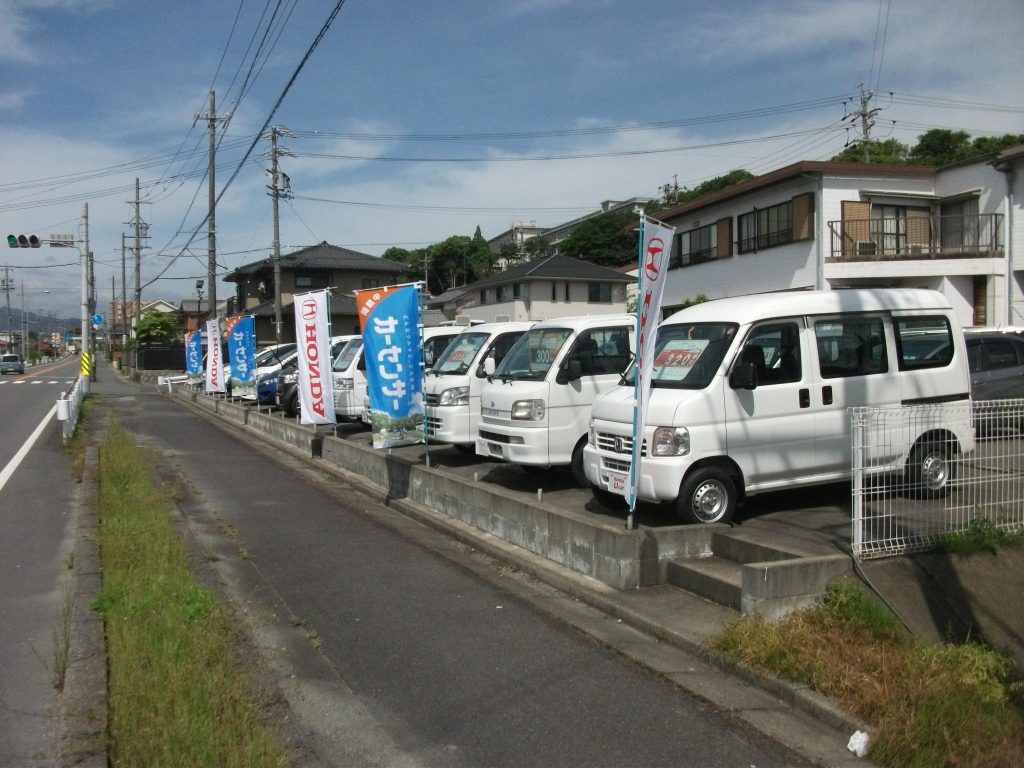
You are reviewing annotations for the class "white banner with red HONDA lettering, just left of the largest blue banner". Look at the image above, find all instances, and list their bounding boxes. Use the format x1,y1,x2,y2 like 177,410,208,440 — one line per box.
295,289,338,424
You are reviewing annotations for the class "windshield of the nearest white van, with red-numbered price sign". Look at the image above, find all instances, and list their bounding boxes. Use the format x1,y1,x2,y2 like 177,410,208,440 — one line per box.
624,323,738,389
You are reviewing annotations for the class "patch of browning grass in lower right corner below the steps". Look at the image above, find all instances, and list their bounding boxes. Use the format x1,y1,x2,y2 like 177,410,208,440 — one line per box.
714,583,1024,768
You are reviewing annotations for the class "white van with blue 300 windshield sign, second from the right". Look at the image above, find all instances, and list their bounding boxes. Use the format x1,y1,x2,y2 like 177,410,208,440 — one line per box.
476,314,636,486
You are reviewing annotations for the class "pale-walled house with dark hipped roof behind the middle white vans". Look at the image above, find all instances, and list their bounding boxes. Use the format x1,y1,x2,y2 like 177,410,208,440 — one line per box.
436,254,636,322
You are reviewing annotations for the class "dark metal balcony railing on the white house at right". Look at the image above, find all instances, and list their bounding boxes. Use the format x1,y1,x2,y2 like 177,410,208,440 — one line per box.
828,213,1005,261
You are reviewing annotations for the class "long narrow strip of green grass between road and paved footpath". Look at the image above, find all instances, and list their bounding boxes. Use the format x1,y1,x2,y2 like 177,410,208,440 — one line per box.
95,423,287,768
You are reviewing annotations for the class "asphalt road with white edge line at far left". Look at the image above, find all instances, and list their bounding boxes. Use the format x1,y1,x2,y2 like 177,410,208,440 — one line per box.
0,357,79,768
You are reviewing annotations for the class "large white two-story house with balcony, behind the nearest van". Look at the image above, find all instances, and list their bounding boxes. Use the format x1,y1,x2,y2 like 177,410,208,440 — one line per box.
657,147,1024,326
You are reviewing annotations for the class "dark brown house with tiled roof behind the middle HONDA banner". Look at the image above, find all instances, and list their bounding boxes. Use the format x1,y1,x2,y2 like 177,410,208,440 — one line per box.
224,242,409,344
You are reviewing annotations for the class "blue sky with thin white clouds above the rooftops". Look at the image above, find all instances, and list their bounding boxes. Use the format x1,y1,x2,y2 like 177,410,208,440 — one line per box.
0,0,1024,326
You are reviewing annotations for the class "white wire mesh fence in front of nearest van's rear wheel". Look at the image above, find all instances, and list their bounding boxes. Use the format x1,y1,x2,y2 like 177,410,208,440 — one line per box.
851,399,1024,559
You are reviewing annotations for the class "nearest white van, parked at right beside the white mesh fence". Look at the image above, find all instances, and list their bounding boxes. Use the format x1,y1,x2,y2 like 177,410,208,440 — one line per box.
584,289,974,522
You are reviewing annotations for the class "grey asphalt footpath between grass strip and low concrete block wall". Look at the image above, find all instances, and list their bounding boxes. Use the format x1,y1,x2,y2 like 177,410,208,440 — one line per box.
99,370,804,768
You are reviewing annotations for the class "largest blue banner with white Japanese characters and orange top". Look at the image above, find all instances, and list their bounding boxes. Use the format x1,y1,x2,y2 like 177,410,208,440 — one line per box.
355,286,426,449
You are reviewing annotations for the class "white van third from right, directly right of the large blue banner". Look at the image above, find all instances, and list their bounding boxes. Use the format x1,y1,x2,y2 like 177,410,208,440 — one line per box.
423,323,534,451
